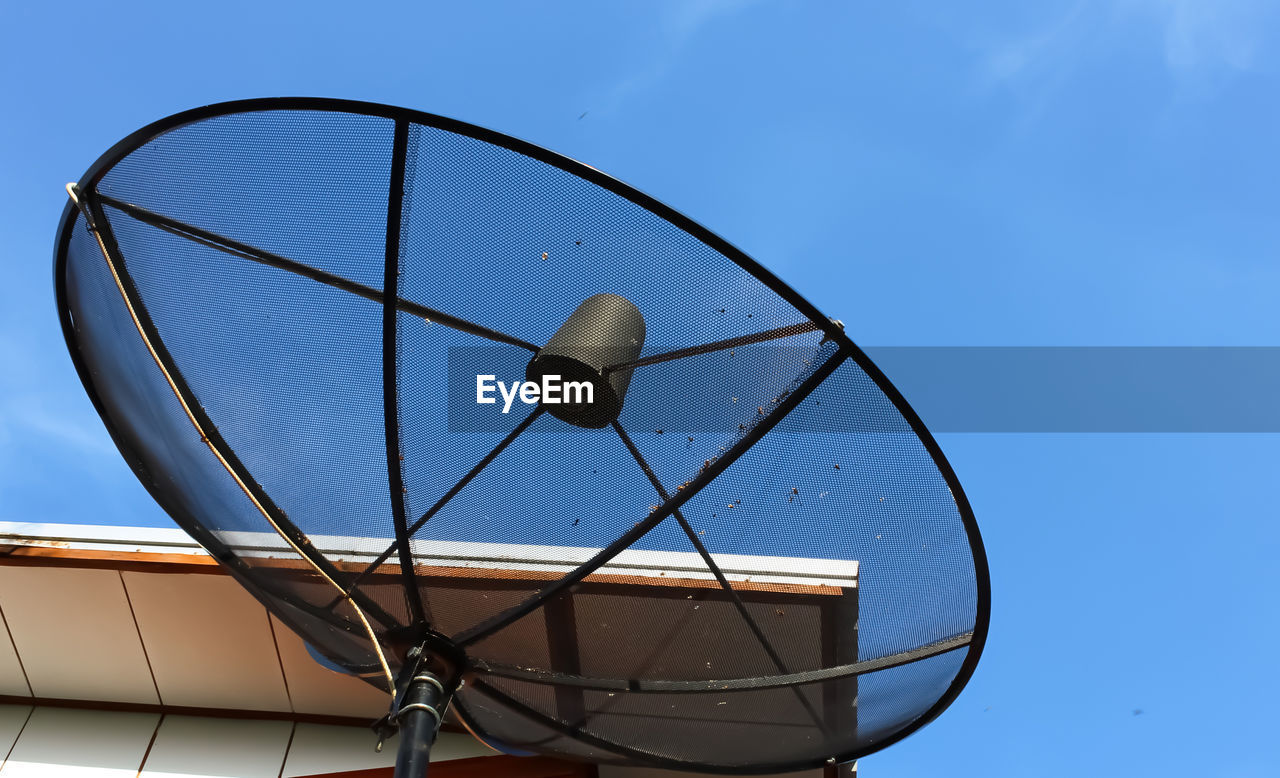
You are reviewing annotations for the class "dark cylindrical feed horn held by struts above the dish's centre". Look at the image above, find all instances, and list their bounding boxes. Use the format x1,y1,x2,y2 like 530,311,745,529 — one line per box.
525,294,644,430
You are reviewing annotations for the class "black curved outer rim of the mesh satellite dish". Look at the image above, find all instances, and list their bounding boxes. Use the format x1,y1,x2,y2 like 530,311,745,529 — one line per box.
54,97,991,773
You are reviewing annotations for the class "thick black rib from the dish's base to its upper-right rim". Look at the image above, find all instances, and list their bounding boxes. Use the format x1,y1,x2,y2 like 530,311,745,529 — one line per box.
454,348,845,649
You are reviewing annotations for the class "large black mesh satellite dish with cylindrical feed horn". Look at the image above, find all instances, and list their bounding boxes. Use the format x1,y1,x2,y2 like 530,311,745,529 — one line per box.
55,99,989,775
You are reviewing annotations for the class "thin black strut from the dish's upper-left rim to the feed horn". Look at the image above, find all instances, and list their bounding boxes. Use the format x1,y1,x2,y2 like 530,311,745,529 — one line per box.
96,193,538,352
